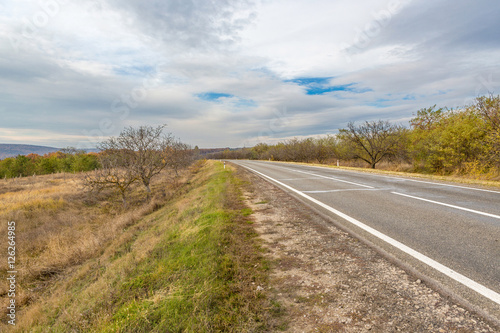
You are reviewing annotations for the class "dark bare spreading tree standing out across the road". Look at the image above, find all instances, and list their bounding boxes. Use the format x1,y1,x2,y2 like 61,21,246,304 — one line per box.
339,120,400,169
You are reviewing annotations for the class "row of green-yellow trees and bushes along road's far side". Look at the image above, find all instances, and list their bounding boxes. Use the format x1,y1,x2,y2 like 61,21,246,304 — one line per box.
210,94,500,176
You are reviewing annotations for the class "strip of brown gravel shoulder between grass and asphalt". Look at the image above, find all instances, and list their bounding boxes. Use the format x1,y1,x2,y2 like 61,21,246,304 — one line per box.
236,167,499,332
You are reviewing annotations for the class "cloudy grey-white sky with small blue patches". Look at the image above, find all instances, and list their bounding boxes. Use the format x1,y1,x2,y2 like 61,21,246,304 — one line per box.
0,0,500,148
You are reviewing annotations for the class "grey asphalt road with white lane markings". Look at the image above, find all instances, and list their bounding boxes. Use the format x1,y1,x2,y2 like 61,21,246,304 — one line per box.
231,161,500,323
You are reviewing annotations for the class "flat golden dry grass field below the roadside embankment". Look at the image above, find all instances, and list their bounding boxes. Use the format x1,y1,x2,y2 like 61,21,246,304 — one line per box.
0,166,189,322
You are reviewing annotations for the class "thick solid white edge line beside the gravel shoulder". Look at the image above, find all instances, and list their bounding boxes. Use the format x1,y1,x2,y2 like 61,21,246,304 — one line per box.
240,166,500,304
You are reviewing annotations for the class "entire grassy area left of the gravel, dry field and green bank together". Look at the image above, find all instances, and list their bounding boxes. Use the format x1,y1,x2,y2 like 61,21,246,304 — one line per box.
0,162,278,332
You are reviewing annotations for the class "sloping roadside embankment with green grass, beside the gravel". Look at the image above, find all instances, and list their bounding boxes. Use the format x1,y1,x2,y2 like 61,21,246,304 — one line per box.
23,163,282,332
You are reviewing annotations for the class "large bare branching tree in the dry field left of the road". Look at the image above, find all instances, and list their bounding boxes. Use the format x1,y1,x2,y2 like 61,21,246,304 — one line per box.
99,125,174,195
